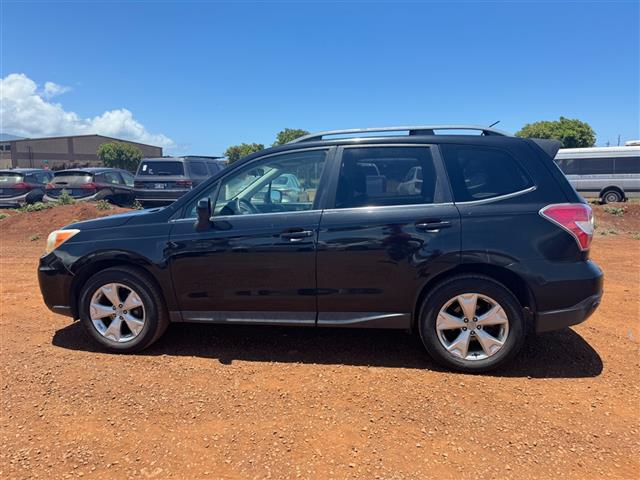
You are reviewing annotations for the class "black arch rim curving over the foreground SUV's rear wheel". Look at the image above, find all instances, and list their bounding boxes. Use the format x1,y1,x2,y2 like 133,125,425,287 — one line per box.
411,263,536,332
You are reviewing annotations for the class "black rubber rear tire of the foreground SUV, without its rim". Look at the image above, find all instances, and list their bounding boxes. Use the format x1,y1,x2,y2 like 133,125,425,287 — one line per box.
419,274,526,373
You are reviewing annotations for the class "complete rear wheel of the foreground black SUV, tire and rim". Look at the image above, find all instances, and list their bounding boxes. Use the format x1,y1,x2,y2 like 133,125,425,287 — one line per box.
419,274,526,373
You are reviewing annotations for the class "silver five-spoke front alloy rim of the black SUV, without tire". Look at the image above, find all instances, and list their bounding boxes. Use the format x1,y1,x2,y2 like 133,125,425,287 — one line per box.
89,283,145,343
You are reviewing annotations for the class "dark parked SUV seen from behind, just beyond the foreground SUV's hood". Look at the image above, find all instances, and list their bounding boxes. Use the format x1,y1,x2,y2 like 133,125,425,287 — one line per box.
134,156,225,207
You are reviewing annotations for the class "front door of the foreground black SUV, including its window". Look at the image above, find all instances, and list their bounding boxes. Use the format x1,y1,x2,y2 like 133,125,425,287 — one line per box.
169,149,329,325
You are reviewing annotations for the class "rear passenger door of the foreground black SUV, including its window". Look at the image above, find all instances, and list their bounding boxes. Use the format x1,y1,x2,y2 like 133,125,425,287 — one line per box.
318,144,460,328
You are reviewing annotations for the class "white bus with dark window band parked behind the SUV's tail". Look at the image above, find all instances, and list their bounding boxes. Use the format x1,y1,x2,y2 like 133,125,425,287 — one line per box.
555,146,640,203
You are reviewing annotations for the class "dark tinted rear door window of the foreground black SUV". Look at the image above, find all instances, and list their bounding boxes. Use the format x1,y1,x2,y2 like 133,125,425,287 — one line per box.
335,147,437,208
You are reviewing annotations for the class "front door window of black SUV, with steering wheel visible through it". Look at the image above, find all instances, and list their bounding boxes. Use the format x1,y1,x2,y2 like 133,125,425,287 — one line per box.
185,150,327,218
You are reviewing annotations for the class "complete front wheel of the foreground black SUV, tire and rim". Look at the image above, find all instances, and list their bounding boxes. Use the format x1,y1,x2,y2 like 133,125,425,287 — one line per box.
78,266,169,353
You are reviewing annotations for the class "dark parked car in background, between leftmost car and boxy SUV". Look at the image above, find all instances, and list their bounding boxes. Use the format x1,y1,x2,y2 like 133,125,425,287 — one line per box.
44,167,134,206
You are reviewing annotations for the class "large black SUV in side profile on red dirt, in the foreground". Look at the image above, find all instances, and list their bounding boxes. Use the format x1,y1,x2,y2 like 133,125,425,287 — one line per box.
39,126,603,372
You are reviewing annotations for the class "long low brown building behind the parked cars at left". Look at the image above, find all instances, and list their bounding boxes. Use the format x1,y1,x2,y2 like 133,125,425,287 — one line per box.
0,135,162,170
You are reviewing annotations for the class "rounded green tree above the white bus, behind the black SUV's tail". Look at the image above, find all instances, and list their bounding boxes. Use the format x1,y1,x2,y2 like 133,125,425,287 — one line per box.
516,117,596,148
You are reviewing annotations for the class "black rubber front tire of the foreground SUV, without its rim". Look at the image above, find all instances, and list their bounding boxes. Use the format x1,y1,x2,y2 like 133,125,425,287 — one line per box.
78,266,169,353
